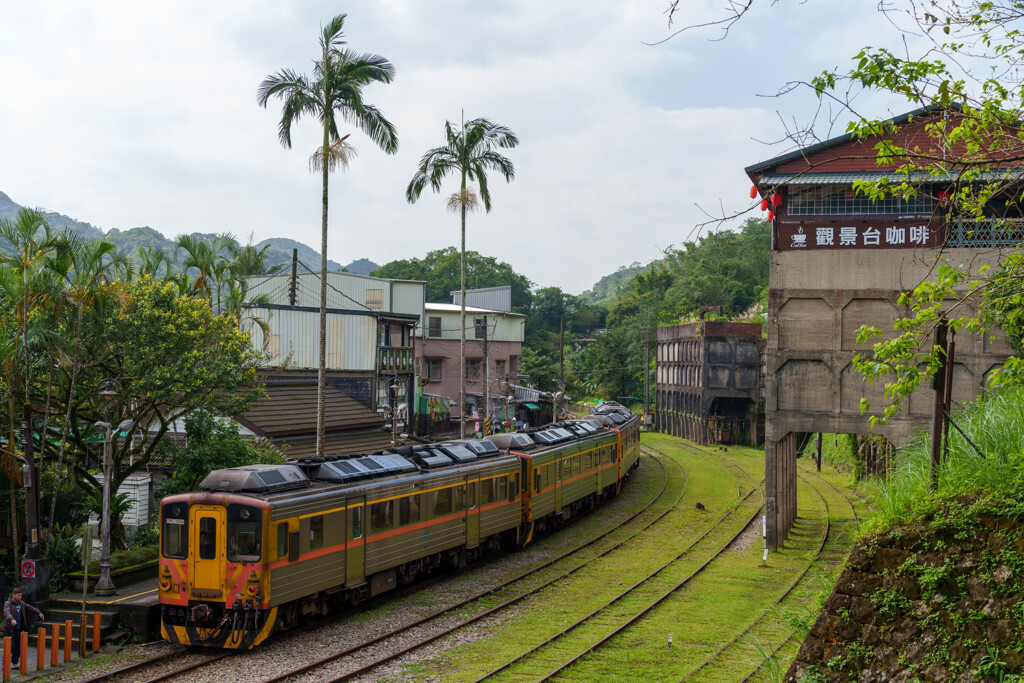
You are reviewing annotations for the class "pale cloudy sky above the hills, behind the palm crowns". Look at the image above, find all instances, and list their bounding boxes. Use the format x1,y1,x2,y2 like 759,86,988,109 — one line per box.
0,0,909,293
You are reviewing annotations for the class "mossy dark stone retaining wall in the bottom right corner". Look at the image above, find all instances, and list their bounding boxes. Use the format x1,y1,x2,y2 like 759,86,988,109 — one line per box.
784,504,1024,683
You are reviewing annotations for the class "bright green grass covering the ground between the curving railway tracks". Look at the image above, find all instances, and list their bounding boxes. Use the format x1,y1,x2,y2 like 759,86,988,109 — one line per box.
404,434,859,681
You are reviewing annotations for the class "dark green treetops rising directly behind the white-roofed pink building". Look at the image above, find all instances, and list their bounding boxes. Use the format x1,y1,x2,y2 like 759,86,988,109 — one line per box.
372,247,532,314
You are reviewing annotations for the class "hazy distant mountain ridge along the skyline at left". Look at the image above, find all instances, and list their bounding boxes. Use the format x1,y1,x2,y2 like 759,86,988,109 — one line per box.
0,191,380,275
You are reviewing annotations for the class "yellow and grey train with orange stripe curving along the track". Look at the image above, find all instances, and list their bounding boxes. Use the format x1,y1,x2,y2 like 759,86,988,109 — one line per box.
158,401,640,649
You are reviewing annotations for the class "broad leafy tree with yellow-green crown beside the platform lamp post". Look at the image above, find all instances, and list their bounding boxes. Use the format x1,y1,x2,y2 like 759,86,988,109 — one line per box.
57,276,262,507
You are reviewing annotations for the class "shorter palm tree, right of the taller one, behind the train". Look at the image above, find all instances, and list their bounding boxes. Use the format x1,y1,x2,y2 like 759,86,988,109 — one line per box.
406,119,519,438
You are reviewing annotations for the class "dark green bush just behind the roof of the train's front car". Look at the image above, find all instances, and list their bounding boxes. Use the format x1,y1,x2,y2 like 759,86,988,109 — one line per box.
157,411,285,498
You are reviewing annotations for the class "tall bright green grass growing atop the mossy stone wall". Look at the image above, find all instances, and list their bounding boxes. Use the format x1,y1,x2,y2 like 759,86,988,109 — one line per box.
863,389,1024,533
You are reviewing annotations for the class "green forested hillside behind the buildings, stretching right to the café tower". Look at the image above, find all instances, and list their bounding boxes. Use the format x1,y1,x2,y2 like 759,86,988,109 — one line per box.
373,218,769,398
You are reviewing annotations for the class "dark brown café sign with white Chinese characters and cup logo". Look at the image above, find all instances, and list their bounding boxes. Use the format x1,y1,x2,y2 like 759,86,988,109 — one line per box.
775,219,942,251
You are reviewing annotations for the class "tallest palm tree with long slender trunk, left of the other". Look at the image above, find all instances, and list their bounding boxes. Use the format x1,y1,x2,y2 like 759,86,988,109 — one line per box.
256,14,398,457
